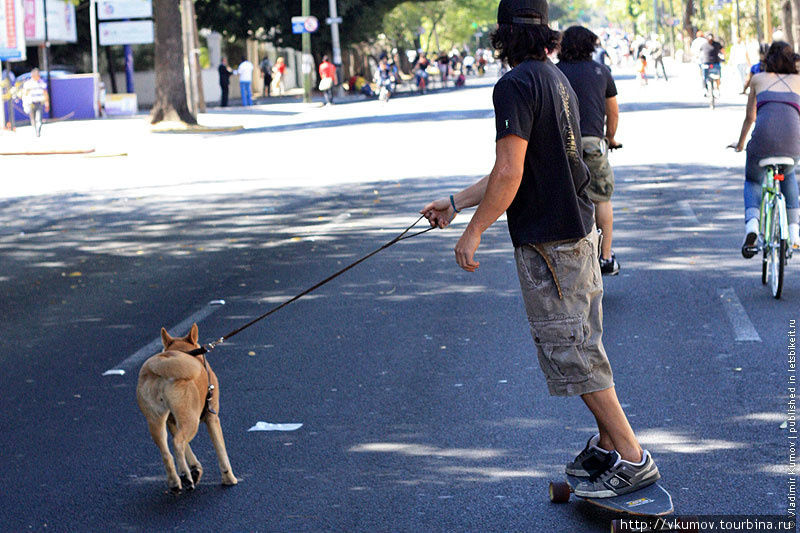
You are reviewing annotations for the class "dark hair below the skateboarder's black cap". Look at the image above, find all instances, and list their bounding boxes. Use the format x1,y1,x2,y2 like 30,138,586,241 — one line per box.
491,24,561,67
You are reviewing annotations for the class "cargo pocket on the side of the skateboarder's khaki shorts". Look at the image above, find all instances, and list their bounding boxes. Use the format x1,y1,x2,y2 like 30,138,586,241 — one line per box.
531,315,591,383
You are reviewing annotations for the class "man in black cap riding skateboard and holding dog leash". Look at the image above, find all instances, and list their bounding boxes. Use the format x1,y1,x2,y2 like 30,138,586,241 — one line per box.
421,0,660,498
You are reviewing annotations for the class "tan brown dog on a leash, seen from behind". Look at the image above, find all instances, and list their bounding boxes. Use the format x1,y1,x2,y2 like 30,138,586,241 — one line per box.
136,324,237,492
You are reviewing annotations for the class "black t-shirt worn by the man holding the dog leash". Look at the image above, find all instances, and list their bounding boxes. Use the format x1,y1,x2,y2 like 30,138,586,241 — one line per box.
492,60,594,246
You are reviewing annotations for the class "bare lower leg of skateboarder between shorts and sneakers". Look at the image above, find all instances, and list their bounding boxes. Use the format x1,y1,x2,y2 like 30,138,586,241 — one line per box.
581,387,642,463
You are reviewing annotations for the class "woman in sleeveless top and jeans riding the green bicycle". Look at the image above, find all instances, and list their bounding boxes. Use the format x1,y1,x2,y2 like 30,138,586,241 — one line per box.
730,41,800,254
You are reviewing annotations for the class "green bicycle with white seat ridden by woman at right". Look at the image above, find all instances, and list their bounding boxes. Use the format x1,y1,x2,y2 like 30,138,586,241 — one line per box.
757,157,795,299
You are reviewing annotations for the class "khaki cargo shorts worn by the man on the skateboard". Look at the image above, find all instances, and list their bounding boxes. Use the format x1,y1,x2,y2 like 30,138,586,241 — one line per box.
514,229,614,396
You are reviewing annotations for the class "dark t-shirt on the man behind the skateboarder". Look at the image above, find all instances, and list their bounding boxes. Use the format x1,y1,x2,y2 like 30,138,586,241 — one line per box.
558,61,617,137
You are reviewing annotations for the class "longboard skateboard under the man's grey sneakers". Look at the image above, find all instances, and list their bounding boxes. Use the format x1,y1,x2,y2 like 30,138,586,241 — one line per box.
550,475,674,533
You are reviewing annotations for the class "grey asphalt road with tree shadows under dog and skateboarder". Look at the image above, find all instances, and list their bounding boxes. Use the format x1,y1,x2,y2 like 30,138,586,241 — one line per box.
0,60,800,532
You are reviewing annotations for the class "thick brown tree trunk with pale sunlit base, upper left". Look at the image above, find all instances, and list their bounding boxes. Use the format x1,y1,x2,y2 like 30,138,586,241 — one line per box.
150,0,197,124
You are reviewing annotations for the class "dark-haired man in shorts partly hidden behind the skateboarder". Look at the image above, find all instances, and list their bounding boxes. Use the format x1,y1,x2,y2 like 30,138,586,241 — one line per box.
558,26,619,276
